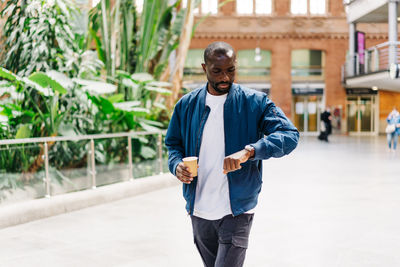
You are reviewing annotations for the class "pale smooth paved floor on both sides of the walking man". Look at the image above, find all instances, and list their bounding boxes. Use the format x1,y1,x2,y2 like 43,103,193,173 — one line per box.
0,136,400,267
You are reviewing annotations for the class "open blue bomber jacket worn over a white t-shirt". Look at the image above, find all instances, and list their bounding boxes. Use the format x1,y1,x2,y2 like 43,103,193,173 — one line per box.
165,84,299,216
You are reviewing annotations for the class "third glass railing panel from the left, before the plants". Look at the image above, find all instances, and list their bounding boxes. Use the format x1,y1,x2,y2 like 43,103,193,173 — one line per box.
94,137,130,186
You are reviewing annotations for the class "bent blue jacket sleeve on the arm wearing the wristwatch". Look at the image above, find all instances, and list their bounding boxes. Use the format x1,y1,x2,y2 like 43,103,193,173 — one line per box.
250,97,299,160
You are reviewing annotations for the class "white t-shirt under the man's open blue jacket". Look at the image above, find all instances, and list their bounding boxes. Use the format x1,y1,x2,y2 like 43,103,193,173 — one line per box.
193,92,232,220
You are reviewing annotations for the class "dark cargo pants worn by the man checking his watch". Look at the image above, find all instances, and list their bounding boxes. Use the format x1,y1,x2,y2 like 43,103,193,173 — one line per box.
191,214,254,267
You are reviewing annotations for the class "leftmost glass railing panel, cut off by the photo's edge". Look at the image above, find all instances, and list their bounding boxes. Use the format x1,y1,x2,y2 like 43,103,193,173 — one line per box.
0,144,46,205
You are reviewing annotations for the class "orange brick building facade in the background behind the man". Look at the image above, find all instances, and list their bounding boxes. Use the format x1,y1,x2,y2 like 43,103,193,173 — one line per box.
189,0,387,134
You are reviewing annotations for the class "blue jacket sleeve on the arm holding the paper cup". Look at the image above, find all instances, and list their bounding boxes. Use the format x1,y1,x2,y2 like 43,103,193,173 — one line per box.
165,102,185,175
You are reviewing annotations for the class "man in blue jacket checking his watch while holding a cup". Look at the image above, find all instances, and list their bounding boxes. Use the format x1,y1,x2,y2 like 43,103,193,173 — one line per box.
165,42,299,267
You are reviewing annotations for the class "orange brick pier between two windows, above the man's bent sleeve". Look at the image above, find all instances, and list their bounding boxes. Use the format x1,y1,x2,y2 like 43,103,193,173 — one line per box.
270,39,292,118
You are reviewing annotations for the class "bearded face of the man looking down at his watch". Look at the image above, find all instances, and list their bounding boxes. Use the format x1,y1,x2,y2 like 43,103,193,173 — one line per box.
202,51,236,95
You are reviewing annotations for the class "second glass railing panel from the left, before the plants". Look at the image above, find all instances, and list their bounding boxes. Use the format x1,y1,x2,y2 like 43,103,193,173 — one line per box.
48,140,92,196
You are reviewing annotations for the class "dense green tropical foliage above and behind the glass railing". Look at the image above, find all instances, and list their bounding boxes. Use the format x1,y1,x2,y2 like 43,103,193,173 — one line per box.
0,0,195,198
